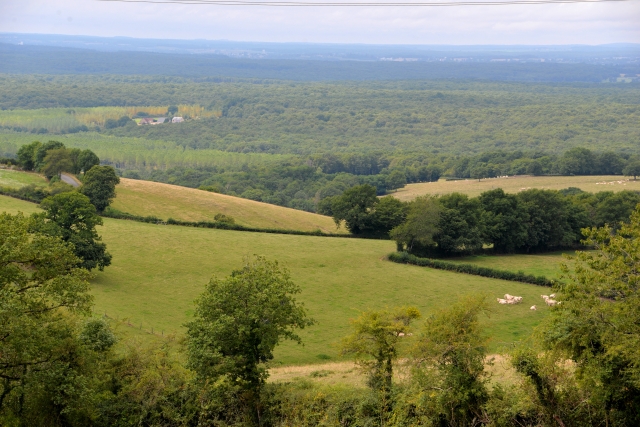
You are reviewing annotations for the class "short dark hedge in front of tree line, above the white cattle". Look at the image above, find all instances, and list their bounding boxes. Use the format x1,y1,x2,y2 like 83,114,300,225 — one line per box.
389,252,554,287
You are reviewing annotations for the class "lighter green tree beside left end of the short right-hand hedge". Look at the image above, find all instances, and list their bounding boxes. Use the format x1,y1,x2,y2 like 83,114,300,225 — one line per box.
390,196,442,252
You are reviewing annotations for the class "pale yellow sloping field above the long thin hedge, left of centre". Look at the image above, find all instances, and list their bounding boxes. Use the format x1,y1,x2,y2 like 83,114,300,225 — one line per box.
112,178,346,233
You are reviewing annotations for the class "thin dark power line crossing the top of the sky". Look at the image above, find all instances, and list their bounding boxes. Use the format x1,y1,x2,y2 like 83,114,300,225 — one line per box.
96,0,630,7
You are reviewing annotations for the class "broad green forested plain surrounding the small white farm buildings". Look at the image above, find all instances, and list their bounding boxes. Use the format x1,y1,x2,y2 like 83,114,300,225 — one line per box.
0,75,640,211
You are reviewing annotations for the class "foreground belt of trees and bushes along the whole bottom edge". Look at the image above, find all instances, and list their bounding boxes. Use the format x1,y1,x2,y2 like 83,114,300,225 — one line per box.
0,209,640,427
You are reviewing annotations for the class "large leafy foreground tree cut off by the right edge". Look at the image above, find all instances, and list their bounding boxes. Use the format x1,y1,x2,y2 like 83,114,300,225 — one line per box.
529,208,640,425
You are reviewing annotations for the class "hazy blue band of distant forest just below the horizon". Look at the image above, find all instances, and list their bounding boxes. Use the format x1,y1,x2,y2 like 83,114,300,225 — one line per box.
0,43,637,82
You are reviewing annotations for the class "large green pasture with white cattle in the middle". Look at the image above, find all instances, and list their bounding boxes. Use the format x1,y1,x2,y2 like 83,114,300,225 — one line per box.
0,197,547,364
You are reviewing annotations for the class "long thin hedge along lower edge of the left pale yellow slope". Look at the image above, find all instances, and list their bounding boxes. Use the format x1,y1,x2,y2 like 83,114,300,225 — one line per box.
102,207,376,238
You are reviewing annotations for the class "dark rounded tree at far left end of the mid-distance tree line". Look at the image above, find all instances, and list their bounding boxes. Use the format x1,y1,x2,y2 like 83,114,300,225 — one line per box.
331,184,378,234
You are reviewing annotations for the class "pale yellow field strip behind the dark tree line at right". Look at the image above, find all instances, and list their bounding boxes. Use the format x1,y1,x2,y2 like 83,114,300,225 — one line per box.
391,175,640,201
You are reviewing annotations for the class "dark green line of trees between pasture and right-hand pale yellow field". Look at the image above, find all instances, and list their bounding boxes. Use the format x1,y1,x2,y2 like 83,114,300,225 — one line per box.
328,185,640,257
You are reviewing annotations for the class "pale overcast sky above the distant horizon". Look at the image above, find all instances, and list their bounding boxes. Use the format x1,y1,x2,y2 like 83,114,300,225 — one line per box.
0,0,640,44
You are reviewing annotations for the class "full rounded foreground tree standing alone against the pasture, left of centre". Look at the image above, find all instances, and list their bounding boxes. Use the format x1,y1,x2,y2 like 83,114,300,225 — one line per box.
187,256,313,422
